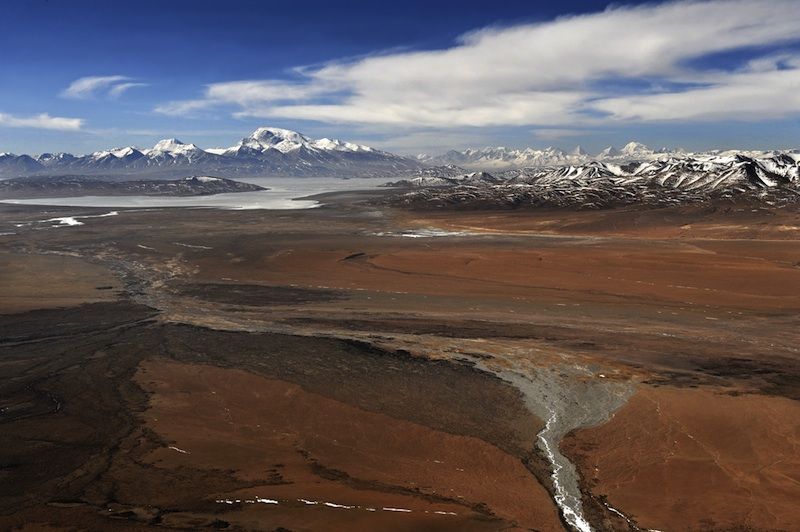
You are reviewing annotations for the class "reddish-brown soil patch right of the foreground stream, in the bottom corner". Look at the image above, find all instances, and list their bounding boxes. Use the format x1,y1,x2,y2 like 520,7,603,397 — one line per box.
562,387,800,531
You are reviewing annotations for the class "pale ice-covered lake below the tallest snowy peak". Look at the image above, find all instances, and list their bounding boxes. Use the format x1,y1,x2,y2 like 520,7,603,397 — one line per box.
3,177,389,209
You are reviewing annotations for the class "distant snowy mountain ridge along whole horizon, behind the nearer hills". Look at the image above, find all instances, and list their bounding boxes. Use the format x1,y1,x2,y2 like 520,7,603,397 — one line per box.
6,133,798,180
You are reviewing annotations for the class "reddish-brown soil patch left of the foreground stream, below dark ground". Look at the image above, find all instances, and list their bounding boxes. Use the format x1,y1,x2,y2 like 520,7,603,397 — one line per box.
136,361,561,530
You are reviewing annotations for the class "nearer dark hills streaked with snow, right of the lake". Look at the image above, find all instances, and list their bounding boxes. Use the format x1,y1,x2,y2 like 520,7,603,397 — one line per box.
390,151,800,208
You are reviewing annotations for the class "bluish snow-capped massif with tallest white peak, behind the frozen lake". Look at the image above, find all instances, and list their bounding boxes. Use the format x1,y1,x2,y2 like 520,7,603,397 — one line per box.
0,127,422,178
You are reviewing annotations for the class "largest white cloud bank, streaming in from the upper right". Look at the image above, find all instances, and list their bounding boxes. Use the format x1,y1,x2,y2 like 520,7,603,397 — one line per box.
157,0,800,128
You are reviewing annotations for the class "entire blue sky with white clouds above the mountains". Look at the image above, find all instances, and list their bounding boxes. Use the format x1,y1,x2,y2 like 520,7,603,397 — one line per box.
0,0,800,153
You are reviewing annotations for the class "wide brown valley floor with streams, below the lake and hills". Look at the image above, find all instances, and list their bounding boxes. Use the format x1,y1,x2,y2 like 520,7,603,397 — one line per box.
0,192,800,531
